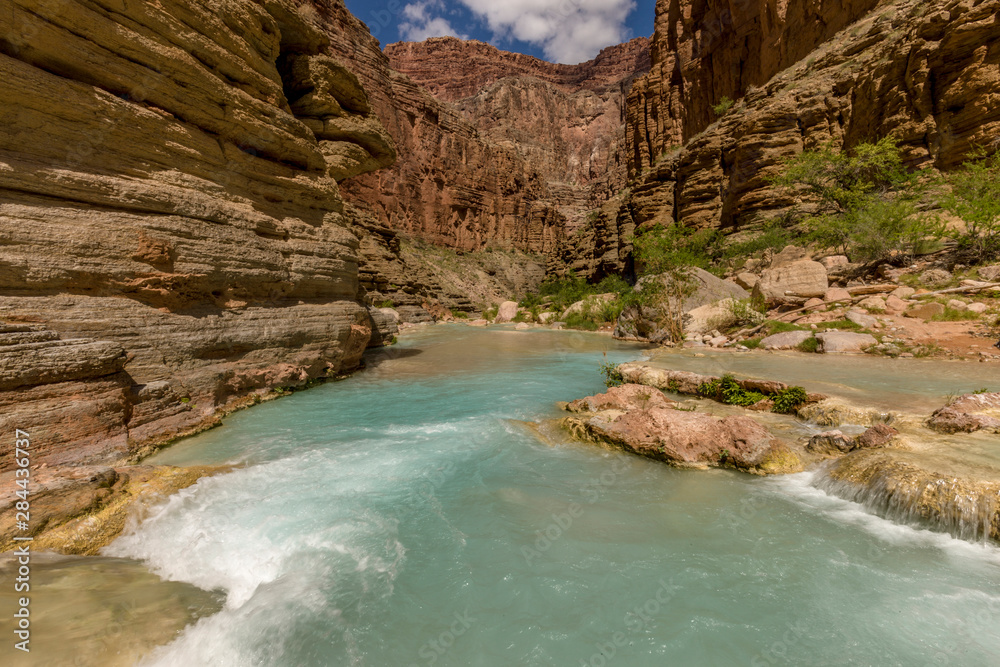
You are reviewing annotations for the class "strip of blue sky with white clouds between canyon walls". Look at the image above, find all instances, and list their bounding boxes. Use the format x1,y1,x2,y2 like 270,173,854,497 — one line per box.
345,0,656,64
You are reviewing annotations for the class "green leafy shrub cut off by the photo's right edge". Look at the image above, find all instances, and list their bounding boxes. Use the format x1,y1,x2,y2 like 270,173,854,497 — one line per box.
942,149,1000,262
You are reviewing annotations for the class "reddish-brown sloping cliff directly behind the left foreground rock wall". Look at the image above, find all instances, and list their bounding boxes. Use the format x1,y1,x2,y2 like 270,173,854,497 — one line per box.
296,0,564,253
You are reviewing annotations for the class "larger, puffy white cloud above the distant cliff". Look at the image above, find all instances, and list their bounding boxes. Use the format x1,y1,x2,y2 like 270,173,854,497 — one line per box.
456,0,635,64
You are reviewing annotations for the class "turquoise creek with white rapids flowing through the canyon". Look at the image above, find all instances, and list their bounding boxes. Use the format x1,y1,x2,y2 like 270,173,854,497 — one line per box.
94,326,1000,667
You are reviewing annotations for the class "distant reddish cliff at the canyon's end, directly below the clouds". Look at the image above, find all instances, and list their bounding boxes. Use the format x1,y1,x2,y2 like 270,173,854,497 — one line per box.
386,37,649,224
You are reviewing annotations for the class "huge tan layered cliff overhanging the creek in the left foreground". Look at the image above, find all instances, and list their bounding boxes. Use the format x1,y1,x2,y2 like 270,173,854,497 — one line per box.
0,0,395,467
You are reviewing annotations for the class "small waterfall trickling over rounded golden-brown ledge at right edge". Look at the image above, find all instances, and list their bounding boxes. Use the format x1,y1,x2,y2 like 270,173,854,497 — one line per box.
812,455,1000,542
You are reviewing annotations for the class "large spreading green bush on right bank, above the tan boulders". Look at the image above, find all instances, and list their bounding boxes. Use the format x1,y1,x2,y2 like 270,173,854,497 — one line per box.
773,137,944,262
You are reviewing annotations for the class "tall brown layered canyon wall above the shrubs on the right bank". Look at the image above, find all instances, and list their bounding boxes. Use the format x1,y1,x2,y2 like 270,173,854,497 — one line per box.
626,0,1000,232
